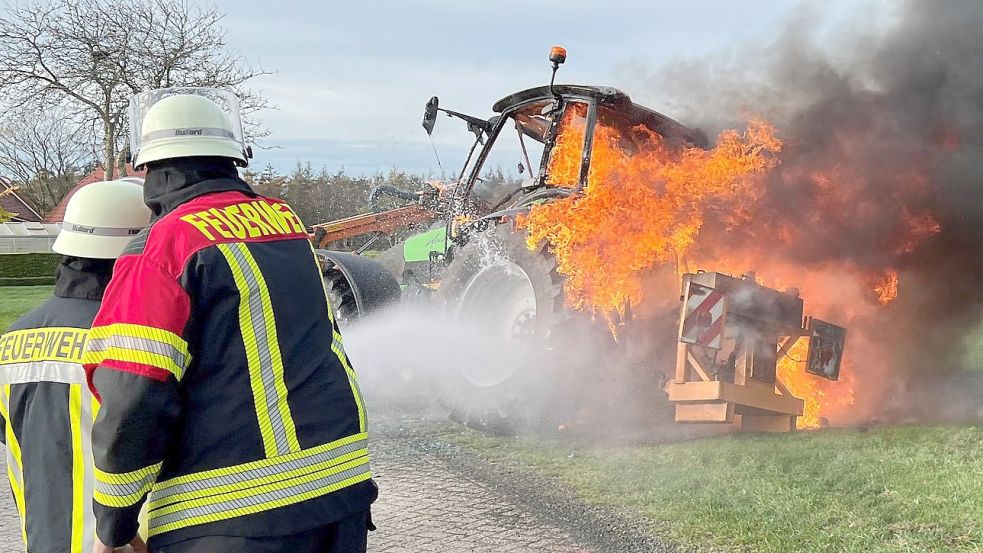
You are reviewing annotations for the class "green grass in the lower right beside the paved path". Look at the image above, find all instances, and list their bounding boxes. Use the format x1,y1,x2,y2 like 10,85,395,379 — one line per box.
450,426,983,552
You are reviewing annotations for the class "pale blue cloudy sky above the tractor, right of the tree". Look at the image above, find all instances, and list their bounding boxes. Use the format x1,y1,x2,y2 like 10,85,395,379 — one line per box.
214,0,851,175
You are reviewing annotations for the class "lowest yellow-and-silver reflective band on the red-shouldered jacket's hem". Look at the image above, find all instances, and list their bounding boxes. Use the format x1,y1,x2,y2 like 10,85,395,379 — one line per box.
149,457,372,537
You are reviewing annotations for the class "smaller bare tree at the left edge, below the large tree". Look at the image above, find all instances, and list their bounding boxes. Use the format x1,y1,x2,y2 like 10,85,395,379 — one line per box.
0,107,99,213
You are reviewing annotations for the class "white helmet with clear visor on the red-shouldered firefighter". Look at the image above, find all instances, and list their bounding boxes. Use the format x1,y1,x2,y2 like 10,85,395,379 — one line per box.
130,88,249,169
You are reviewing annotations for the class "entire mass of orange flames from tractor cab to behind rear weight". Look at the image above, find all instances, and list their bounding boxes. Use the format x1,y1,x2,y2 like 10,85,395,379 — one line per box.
518,106,940,428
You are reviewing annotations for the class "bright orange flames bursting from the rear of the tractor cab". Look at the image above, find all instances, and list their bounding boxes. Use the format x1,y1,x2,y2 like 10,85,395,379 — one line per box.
520,110,781,315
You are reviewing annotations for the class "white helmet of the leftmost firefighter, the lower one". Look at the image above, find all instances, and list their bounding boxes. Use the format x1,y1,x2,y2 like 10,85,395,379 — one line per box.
51,180,150,259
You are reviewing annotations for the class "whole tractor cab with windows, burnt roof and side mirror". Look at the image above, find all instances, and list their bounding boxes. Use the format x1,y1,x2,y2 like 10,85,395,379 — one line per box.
423,85,707,216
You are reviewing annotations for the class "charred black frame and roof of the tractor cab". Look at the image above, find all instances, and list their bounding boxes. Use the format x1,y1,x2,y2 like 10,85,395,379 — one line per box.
423,85,708,252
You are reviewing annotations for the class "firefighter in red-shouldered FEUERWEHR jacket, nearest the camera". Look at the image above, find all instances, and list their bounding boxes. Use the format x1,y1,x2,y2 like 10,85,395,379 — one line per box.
84,89,377,553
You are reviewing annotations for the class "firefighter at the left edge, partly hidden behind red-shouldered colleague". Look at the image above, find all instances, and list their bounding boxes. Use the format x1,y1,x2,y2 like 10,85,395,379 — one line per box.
0,181,150,553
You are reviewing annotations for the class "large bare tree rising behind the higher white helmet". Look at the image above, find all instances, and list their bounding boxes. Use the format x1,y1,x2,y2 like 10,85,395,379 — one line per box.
0,0,268,178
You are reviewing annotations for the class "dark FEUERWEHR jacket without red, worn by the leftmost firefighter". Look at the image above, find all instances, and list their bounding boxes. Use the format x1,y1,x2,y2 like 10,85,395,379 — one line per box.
0,257,113,553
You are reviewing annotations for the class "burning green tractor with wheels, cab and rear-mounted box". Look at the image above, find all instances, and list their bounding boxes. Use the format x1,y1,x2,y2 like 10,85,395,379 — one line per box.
314,48,845,431
